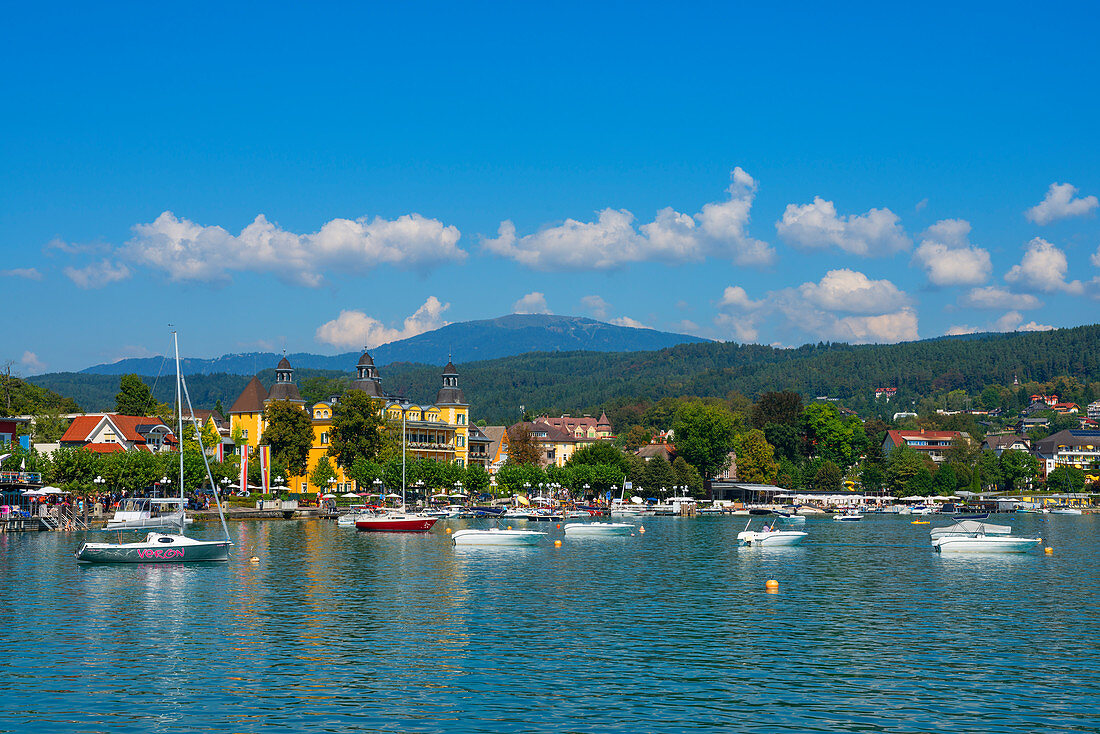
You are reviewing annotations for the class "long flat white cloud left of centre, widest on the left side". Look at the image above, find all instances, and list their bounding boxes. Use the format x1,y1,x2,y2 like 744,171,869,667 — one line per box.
121,211,466,286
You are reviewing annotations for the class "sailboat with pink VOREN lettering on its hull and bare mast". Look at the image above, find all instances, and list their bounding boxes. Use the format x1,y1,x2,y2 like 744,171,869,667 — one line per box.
76,331,233,563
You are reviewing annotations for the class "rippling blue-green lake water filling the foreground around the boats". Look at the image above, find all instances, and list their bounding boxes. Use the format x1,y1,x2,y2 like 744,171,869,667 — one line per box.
0,515,1100,733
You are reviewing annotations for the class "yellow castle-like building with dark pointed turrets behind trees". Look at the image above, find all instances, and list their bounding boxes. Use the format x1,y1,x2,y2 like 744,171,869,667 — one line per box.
229,352,477,493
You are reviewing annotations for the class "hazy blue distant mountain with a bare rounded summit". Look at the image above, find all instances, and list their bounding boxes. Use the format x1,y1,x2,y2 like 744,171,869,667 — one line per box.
80,314,705,376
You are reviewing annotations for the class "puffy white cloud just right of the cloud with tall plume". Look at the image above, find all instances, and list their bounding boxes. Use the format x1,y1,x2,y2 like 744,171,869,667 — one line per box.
776,196,911,256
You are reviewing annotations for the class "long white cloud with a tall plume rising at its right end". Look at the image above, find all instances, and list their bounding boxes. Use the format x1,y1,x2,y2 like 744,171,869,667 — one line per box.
482,167,776,271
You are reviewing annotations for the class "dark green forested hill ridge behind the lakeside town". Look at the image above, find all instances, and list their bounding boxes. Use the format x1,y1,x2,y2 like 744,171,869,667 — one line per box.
32,326,1100,423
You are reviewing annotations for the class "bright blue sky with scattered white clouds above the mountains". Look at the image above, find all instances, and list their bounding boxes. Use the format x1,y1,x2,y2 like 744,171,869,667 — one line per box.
0,3,1100,375
